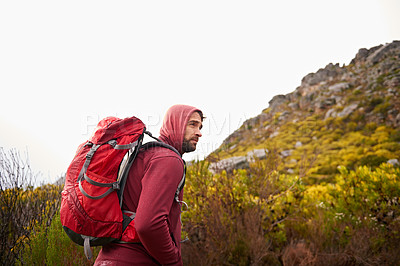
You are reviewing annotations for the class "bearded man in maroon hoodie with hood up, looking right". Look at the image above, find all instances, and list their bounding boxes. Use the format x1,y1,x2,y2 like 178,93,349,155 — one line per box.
95,105,203,265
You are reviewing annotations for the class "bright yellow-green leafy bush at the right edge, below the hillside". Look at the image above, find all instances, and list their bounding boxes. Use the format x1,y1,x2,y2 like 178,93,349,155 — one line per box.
332,164,400,232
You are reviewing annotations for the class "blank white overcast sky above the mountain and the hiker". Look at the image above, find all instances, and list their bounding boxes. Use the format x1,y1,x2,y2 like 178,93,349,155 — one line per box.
0,0,400,182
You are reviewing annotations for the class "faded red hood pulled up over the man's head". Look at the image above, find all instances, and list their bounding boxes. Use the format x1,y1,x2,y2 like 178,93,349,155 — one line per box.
160,104,202,154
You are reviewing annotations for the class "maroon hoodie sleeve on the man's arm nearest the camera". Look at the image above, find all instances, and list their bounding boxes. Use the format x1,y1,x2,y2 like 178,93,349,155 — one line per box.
135,153,183,265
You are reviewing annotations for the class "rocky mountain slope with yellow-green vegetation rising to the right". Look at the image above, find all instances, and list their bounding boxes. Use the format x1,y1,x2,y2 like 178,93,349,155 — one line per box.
207,41,400,182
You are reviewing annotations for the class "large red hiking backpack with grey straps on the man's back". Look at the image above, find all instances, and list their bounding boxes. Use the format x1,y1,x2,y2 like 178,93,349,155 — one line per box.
60,117,185,259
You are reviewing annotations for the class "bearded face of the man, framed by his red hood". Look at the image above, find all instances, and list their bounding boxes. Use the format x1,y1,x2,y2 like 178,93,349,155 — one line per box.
182,112,203,152
